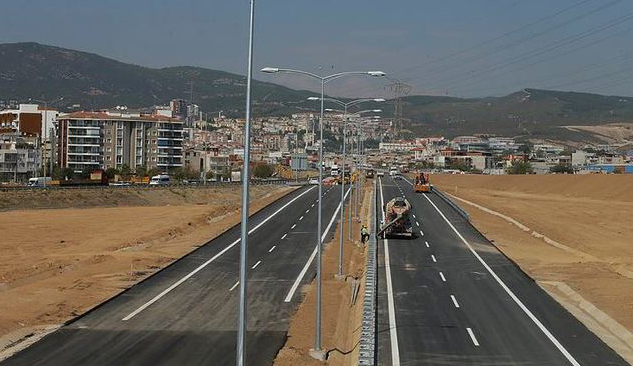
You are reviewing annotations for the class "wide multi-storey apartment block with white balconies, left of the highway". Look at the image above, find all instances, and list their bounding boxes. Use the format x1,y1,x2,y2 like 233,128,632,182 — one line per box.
58,111,184,172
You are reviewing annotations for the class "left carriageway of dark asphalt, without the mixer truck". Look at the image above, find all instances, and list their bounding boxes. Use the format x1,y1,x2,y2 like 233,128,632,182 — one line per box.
0,186,348,366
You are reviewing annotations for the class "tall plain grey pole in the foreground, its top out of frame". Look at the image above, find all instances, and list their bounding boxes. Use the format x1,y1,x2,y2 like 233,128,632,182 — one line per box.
235,0,255,366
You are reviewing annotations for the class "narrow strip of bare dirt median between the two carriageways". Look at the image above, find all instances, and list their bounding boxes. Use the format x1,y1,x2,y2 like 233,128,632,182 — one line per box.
273,186,371,366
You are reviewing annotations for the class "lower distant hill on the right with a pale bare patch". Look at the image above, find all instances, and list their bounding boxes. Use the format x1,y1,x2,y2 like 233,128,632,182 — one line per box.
404,89,633,141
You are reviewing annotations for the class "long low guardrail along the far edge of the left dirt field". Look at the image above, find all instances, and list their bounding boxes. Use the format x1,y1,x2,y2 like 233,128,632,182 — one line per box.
0,179,294,192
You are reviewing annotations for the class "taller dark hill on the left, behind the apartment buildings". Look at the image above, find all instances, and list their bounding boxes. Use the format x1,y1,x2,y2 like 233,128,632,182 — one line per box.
0,43,313,113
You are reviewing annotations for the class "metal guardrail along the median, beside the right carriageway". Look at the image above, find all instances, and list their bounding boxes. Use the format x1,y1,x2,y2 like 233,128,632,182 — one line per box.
358,181,378,366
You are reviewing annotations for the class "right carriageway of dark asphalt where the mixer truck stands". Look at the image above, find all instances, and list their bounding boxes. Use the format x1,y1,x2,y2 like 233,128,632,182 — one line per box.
377,177,628,366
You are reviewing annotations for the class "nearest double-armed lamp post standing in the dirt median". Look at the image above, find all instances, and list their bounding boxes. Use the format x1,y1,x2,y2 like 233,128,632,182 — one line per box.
261,67,386,360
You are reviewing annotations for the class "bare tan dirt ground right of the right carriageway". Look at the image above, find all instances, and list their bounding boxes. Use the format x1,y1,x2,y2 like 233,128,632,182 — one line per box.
431,175,633,360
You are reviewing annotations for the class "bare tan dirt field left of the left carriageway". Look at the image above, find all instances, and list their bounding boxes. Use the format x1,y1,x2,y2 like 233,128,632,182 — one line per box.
0,186,291,353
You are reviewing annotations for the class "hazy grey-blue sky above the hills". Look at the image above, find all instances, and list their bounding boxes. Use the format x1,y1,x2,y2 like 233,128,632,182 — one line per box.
0,0,633,96
